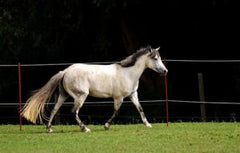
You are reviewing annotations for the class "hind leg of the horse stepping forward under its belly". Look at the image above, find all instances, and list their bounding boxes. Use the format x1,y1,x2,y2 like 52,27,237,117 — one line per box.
73,93,90,132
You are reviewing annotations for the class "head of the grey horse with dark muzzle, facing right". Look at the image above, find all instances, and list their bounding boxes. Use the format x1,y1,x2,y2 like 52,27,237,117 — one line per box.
146,47,168,75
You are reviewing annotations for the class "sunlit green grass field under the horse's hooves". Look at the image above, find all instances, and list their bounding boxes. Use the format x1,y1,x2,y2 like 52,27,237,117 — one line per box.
0,123,240,153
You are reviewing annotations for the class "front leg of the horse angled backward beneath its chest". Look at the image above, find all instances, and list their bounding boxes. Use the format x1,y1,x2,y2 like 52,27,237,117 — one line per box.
104,98,123,130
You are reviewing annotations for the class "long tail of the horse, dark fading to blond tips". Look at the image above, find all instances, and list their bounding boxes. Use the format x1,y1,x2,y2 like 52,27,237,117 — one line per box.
21,71,64,123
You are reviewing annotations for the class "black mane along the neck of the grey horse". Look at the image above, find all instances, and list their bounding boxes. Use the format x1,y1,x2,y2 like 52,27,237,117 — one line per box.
117,46,152,67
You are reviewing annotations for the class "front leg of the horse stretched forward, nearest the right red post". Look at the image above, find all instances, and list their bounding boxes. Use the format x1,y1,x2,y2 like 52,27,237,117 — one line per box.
129,92,152,128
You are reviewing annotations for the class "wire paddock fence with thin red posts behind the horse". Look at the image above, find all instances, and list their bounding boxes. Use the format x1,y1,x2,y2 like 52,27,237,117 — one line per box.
0,59,240,124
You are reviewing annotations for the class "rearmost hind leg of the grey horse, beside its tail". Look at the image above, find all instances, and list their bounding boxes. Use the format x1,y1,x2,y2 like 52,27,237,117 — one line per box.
47,87,68,133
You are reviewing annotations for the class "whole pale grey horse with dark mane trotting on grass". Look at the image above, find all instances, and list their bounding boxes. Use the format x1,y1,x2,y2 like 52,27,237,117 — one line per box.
21,46,168,133
